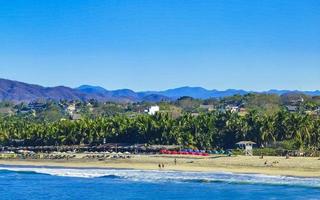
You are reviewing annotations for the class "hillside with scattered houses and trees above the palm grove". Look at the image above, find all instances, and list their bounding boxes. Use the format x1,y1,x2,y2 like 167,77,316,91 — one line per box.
0,93,320,119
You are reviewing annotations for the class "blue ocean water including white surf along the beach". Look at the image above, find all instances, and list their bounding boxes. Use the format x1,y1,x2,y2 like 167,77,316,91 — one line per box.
0,166,320,200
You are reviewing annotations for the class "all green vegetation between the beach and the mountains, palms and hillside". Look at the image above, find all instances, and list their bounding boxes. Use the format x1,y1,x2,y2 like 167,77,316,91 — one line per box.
0,94,320,152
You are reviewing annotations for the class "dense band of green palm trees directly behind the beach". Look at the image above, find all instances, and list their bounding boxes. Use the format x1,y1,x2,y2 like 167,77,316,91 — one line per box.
0,110,320,149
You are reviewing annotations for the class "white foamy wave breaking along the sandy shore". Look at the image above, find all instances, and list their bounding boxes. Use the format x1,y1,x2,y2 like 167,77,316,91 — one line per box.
0,166,320,188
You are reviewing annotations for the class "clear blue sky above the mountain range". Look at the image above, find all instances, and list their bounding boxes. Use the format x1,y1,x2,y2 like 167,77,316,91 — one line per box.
0,0,320,90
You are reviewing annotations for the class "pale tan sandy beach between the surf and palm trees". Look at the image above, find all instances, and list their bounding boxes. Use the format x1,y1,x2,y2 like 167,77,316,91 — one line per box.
0,155,320,177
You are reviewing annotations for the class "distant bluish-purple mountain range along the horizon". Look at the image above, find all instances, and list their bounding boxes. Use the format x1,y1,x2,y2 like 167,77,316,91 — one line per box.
0,79,320,102
